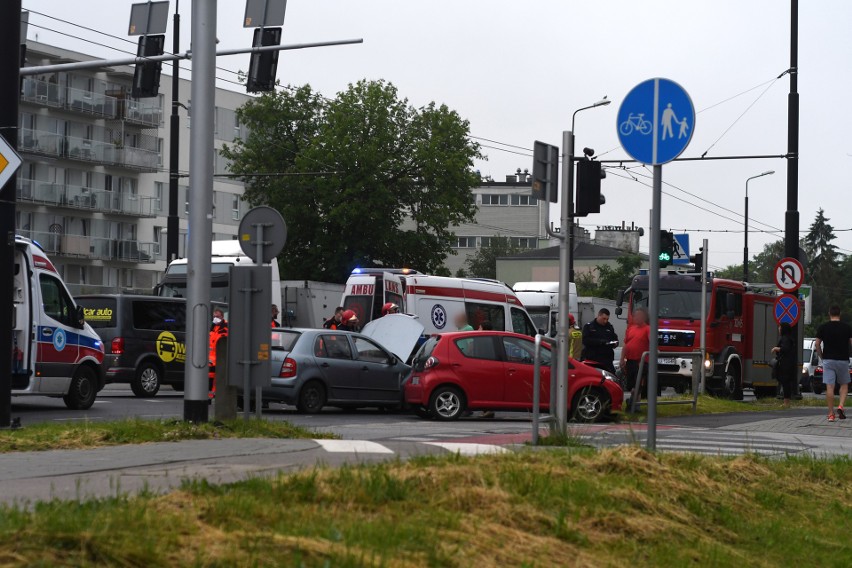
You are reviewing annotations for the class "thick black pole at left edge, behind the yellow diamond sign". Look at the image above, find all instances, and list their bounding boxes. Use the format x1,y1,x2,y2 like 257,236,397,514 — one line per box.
0,0,26,428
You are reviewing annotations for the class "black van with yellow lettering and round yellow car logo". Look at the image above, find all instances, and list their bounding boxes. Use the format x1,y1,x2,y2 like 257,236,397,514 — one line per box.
74,294,186,397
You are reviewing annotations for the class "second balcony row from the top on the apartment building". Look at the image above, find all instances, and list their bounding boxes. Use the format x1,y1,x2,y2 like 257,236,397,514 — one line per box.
18,128,160,171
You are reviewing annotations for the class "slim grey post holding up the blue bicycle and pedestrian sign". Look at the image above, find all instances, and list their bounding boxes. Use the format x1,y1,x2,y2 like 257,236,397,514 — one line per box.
647,165,663,451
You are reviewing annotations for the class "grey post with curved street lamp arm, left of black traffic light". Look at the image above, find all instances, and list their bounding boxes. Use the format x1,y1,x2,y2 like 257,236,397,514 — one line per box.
551,99,611,433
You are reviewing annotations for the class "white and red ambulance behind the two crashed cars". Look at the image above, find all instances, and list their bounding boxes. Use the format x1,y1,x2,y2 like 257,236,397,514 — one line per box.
341,268,536,337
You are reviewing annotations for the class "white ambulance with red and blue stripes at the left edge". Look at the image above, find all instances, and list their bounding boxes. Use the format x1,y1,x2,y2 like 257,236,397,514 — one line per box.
12,236,104,410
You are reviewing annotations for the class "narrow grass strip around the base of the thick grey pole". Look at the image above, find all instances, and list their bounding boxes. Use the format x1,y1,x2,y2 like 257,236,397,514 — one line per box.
0,418,331,453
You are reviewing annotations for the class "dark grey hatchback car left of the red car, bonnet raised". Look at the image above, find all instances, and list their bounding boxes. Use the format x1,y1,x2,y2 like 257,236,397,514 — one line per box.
263,328,411,413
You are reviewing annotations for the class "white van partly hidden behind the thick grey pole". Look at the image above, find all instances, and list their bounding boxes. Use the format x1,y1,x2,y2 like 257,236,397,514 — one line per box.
154,240,282,310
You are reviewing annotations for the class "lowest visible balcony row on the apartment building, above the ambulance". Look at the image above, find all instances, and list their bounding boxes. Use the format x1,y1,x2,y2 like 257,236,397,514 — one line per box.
18,231,158,264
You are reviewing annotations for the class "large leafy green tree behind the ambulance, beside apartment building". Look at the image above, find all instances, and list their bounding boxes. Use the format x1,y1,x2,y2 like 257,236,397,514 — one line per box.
222,80,480,281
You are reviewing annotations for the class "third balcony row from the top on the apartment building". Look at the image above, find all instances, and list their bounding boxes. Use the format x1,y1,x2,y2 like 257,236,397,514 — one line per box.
17,178,156,217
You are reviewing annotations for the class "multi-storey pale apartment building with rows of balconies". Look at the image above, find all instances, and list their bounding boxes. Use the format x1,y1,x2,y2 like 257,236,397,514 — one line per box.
16,41,248,293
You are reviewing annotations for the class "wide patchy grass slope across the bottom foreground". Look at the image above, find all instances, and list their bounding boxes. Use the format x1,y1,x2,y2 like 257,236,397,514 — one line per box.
0,447,852,567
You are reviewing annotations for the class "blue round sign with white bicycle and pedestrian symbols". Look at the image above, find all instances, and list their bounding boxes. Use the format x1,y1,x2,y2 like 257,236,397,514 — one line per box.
616,77,695,166
